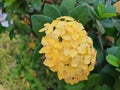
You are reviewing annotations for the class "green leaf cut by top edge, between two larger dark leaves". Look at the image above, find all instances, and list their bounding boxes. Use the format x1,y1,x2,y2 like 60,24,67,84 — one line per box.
60,0,76,10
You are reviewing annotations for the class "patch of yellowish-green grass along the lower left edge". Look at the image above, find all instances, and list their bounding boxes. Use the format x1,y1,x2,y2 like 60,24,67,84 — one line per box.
0,32,26,90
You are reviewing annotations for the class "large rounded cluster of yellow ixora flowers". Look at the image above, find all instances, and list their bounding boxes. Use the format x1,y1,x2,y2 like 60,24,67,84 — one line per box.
39,16,96,84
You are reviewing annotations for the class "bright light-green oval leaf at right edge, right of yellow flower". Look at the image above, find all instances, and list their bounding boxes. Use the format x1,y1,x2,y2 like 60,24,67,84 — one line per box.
106,55,119,67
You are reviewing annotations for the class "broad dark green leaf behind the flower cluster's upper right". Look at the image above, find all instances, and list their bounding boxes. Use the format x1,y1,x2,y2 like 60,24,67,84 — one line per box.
68,5,89,25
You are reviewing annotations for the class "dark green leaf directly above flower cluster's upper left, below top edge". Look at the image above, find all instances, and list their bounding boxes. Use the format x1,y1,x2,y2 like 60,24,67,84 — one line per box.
43,4,61,19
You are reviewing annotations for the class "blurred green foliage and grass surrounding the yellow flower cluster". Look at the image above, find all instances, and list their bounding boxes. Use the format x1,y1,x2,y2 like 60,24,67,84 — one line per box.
0,0,120,90
